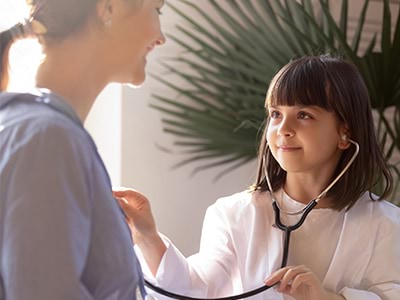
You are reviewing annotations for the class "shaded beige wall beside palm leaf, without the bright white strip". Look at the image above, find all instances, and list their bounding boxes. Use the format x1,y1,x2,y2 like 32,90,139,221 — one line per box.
122,0,256,255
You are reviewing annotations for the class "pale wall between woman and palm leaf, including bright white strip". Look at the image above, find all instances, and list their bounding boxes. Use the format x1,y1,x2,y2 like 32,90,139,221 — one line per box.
85,0,256,255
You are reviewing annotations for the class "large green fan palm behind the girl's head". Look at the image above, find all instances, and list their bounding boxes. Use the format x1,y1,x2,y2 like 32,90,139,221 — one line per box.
152,0,400,204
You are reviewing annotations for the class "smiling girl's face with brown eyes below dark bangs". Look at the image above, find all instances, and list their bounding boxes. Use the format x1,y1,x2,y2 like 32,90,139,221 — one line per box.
267,105,345,176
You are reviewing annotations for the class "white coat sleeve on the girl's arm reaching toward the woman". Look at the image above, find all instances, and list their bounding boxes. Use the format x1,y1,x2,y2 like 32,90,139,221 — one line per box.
136,200,236,298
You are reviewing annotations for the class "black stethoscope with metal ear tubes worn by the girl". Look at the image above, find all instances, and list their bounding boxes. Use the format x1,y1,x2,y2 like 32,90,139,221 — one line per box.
144,138,360,300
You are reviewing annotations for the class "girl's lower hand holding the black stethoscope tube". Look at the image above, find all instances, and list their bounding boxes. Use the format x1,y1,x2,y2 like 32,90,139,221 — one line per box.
265,266,345,300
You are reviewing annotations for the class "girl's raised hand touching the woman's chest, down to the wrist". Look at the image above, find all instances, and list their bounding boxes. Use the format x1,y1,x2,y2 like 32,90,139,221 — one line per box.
113,187,158,244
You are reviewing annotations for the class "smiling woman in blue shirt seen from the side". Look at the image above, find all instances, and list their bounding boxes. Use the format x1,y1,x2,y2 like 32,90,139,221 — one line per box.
0,0,165,300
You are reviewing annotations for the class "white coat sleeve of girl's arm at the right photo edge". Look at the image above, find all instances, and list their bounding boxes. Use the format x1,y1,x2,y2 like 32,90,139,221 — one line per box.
342,215,400,300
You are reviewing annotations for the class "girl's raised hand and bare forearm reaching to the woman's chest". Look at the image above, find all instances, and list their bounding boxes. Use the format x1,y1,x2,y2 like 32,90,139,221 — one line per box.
113,188,167,276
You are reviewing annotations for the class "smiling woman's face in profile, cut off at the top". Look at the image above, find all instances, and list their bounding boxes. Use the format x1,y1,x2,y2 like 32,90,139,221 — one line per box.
105,0,165,85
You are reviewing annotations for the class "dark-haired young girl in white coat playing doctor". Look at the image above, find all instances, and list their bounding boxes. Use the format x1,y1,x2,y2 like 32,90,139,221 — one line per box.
115,56,400,300
